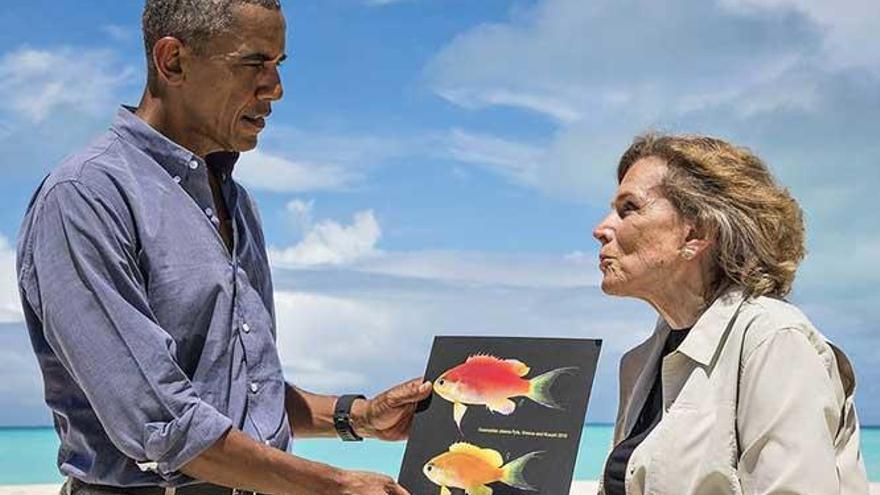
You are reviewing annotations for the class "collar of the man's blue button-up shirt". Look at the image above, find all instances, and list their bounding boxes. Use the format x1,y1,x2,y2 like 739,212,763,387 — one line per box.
110,105,239,178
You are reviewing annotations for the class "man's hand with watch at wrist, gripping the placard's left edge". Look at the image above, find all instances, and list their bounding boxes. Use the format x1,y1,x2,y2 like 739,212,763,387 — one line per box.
351,378,431,442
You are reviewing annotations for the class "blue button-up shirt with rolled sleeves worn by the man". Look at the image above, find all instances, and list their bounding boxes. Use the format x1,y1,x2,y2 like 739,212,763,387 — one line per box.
17,108,290,486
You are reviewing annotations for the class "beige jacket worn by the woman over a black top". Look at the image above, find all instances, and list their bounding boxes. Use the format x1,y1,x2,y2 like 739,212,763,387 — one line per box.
599,289,868,495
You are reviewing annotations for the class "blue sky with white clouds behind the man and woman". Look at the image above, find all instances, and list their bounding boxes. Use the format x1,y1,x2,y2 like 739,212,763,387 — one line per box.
0,0,880,425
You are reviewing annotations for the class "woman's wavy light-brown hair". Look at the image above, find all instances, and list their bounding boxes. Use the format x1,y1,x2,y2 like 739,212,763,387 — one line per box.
617,133,805,300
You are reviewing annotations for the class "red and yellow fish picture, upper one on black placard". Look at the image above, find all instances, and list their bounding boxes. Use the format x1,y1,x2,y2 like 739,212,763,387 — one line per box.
434,354,577,431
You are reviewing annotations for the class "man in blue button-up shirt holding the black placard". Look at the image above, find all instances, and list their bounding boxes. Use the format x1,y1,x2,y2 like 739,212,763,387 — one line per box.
17,0,430,495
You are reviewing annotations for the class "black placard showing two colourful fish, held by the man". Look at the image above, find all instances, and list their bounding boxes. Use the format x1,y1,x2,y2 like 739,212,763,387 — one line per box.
398,337,607,495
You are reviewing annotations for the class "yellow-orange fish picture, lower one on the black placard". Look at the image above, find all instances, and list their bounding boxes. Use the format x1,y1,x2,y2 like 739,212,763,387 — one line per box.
422,442,543,495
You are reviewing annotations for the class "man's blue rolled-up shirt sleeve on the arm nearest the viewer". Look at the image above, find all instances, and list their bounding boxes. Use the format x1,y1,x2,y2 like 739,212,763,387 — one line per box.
21,180,232,478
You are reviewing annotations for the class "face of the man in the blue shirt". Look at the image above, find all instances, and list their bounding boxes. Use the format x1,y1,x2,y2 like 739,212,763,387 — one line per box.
181,4,286,152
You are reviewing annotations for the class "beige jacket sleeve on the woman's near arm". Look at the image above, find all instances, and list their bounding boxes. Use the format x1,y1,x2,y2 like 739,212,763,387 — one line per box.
737,329,841,494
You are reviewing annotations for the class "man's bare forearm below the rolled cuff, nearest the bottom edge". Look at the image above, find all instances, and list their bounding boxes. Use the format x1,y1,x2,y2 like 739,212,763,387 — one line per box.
181,428,343,495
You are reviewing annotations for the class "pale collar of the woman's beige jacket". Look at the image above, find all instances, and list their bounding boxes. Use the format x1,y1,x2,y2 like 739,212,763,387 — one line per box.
672,287,743,366
